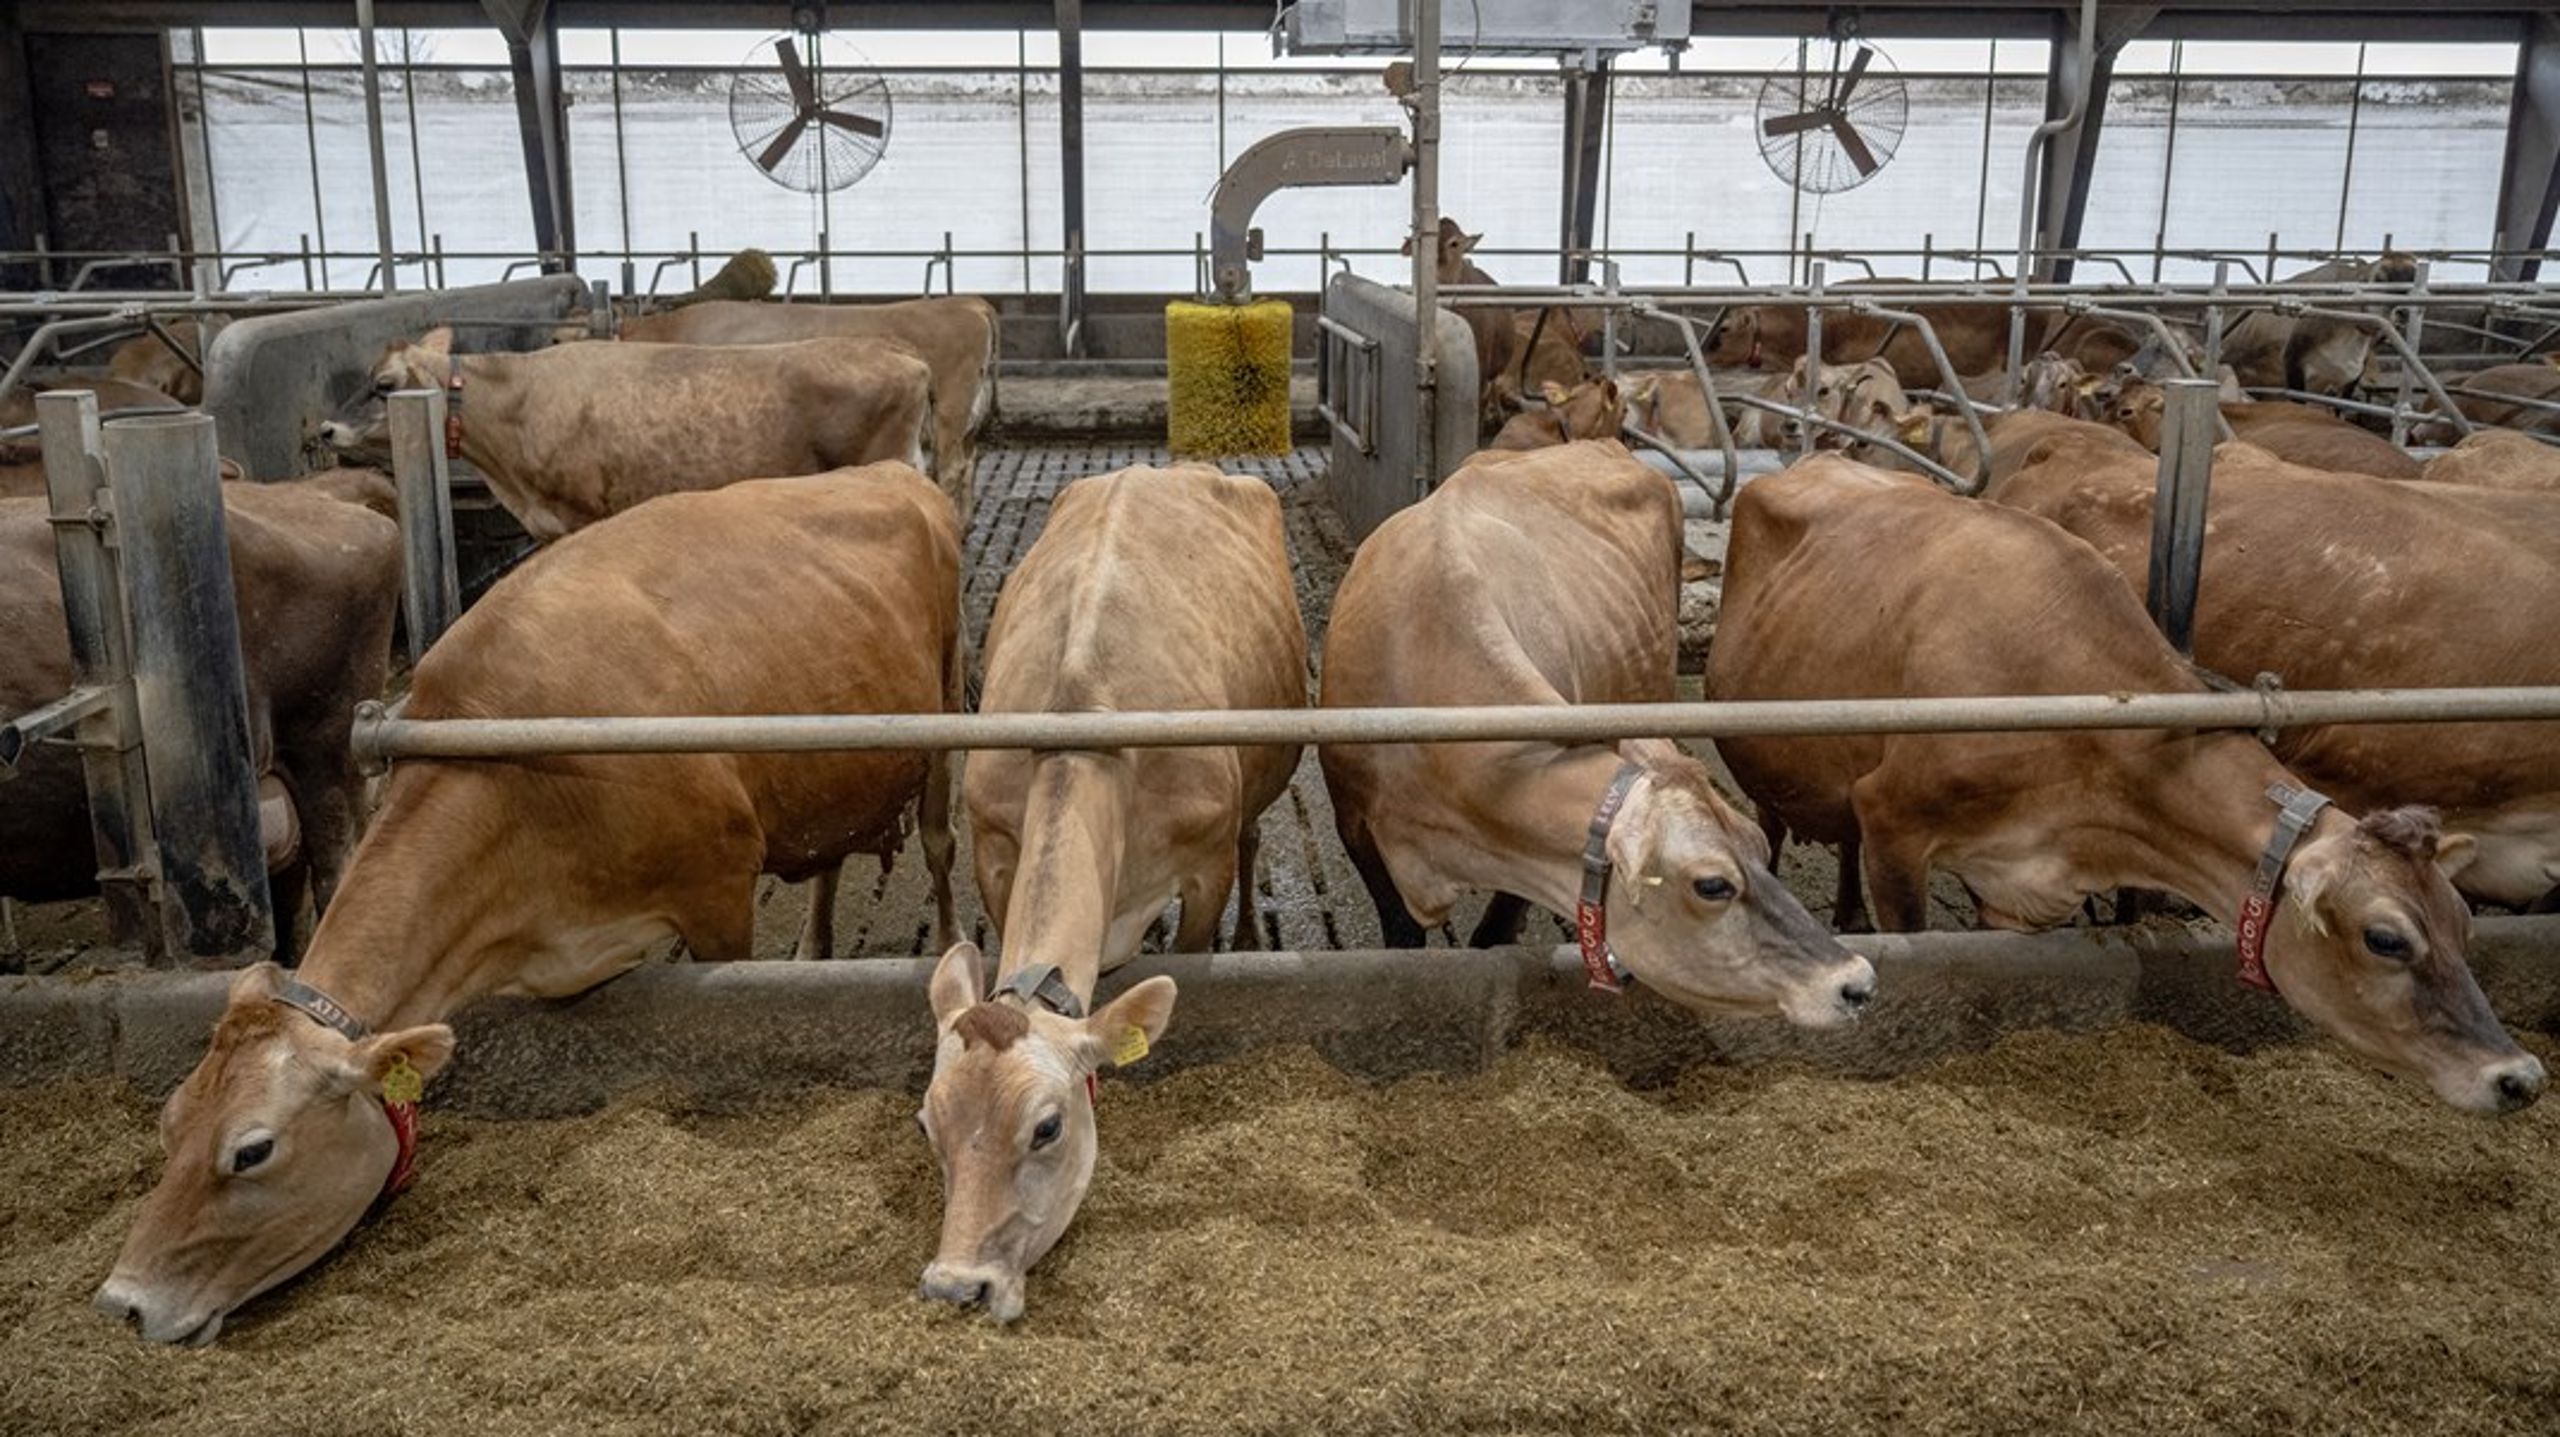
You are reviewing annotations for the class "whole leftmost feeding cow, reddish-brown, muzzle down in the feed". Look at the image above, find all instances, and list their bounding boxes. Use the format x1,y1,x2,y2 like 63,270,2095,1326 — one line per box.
97,466,963,1342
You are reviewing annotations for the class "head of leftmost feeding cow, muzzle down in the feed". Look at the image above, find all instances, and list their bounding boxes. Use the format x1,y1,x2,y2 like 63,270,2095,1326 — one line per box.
97,963,453,1345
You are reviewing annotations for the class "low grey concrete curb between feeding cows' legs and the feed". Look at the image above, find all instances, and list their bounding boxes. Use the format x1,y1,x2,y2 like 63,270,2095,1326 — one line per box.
0,917,2560,1117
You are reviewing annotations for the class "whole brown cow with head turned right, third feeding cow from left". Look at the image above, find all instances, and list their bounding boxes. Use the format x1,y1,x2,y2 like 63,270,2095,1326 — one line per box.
1318,441,1874,1027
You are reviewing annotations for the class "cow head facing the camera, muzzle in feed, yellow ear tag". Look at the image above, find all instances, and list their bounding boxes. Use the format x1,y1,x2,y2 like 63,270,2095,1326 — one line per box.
916,943,1172,1322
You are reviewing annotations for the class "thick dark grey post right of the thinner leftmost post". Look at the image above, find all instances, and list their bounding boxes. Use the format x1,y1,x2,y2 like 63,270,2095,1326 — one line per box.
105,415,276,958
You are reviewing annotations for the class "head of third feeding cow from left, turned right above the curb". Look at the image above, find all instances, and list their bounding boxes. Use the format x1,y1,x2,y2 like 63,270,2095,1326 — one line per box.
1608,740,1876,1027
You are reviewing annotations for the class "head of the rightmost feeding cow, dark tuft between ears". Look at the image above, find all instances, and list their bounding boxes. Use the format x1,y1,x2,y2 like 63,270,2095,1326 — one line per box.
2266,809,2542,1112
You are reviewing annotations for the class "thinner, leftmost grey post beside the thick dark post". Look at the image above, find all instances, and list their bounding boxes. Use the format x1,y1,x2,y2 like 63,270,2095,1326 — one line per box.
36,389,166,963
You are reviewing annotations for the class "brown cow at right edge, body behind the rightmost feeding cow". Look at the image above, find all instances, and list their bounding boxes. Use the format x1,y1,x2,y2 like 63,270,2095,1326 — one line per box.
1994,446,2560,907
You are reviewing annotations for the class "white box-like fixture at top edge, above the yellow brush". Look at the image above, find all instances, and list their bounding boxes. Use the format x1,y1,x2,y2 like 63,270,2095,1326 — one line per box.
1280,0,1690,56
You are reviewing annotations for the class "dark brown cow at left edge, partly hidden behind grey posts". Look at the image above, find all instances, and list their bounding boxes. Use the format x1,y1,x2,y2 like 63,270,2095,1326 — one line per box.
0,474,399,955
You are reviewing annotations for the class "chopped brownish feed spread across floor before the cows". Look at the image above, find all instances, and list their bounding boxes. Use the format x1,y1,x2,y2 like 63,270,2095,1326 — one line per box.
0,1027,2560,1437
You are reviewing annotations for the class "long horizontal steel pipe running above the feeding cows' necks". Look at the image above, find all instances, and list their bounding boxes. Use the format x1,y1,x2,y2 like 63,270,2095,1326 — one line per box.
353,689,2560,763
